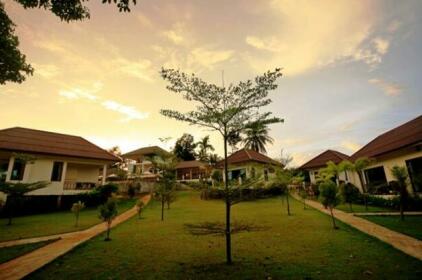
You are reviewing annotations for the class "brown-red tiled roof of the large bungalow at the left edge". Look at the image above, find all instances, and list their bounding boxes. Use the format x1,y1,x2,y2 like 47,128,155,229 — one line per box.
0,127,119,161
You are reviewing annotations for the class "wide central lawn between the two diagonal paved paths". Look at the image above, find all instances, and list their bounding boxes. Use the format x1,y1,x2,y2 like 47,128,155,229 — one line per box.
29,192,422,279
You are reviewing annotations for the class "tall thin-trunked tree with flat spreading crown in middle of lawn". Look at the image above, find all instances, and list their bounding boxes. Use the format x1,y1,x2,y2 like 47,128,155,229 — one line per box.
161,68,283,264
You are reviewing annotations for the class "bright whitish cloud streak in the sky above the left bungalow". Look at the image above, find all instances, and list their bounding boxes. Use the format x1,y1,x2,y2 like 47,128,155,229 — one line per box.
59,82,149,121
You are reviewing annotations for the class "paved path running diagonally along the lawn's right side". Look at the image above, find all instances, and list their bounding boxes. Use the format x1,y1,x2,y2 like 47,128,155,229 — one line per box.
293,194,422,261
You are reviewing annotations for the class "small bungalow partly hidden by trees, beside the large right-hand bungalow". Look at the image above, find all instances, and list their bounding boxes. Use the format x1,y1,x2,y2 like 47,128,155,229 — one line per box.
299,150,351,184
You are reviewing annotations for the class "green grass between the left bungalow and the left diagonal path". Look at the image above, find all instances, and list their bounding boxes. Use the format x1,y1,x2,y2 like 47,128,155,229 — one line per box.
0,199,135,241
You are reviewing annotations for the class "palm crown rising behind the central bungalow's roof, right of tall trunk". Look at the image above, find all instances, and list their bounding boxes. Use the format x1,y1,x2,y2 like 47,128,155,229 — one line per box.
243,122,274,154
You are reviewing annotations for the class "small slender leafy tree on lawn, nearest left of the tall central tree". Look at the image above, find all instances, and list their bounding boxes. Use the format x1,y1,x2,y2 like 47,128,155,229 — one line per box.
151,155,177,221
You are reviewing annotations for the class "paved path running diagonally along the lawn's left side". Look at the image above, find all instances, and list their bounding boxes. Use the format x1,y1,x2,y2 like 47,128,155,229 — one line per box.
0,195,151,280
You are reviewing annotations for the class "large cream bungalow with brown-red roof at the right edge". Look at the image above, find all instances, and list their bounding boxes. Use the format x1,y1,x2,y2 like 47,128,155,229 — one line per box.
351,115,422,193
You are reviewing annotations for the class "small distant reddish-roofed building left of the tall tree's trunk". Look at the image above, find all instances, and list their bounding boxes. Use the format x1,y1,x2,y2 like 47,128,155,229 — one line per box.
176,160,211,181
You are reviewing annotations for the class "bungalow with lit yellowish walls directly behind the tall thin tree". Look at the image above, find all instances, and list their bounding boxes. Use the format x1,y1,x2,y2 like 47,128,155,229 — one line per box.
217,149,283,184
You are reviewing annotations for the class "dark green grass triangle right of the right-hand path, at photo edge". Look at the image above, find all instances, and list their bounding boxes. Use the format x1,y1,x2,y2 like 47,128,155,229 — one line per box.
360,216,422,240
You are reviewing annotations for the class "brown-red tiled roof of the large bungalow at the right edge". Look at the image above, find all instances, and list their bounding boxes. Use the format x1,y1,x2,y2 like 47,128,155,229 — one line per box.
352,115,422,160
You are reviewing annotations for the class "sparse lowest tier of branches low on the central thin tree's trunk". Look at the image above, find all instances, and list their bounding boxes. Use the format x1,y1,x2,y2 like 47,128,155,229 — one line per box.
184,221,268,235
